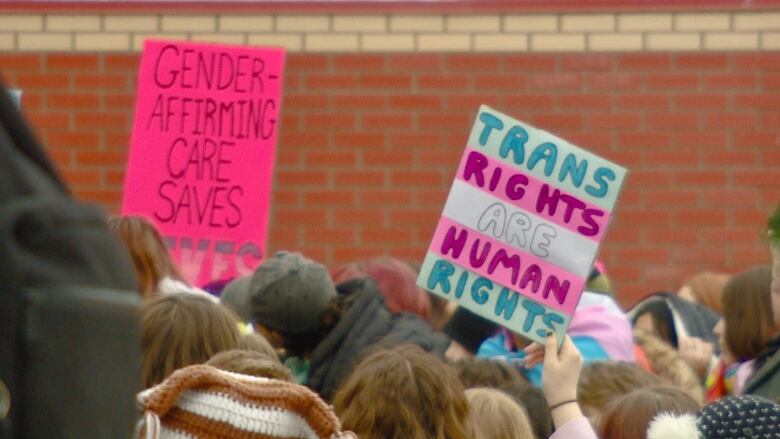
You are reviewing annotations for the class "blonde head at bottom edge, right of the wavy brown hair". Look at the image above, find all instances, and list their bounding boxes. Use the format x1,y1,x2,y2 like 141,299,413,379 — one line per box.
466,387,534,439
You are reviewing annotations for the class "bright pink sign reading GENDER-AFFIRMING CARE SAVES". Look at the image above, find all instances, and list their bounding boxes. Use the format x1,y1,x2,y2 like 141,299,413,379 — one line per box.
122,40,285,285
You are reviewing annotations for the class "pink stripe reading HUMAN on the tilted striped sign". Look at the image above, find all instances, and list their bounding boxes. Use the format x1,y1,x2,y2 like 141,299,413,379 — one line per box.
429,216,585,315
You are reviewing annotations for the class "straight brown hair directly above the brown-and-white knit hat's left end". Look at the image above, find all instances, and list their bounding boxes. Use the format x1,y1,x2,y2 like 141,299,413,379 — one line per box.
141,293,239,388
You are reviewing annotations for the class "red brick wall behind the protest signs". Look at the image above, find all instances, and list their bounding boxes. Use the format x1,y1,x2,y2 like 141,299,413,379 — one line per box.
0,53,780,304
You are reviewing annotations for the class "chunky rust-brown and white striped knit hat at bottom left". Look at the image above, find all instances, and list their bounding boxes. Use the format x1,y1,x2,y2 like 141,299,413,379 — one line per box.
138,365,356,439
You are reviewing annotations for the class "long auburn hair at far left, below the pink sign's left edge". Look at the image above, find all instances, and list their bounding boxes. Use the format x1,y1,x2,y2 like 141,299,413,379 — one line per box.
108,216,182,297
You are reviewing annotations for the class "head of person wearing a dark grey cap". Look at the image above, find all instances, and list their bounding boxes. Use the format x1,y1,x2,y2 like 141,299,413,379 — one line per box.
236,252,341,356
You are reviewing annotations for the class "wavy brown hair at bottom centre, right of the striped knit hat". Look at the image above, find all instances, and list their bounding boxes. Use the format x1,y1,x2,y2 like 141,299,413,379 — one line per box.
333,345,473,439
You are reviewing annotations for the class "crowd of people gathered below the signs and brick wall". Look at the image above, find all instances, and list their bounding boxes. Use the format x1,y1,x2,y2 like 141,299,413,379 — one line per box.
105,208,780,439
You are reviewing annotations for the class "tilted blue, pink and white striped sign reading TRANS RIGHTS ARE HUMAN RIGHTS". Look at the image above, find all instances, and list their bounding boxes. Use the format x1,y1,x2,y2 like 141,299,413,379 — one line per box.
417,106,626,341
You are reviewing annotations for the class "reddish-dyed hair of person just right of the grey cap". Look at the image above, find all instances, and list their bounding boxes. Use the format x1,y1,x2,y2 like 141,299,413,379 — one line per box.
333,256,431,320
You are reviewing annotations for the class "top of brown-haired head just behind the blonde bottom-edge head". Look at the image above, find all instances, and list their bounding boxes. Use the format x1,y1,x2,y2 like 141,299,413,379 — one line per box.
451,357,528,389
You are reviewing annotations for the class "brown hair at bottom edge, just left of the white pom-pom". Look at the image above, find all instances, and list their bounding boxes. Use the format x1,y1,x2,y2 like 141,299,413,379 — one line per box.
598,386,701,439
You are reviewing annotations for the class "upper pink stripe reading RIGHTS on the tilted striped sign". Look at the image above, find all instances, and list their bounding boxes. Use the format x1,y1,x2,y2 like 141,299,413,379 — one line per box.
455,147,610,242
